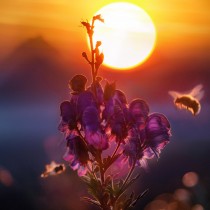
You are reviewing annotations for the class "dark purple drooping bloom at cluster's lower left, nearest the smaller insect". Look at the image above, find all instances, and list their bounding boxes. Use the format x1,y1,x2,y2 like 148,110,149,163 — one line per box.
63,136,89,176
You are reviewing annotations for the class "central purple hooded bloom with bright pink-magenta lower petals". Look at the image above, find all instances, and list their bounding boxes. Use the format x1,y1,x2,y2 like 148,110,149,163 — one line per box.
82,106,108,150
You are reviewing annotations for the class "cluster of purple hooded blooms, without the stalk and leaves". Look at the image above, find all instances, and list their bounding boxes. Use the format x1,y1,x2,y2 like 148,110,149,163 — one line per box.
59,75,170,176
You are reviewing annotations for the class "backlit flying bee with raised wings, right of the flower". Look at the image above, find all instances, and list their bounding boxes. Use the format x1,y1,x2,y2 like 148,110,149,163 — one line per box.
168,84,204,115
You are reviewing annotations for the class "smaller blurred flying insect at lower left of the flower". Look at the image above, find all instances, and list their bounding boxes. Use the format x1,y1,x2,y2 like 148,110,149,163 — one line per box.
41,161,66,178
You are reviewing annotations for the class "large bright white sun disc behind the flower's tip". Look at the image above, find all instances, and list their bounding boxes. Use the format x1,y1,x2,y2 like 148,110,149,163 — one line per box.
93,3,156,70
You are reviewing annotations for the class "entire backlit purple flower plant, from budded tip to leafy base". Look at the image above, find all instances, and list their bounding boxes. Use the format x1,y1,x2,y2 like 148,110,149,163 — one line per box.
59,15,171,210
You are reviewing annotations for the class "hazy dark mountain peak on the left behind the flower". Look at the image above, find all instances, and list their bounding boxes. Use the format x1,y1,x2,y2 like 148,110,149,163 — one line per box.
0,36,70,103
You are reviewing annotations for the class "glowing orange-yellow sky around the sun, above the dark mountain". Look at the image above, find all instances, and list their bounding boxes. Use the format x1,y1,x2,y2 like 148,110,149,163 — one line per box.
0,0,210,63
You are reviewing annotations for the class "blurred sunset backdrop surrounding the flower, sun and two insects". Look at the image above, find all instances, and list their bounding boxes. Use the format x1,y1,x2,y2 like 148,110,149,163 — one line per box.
0,0,210,210
